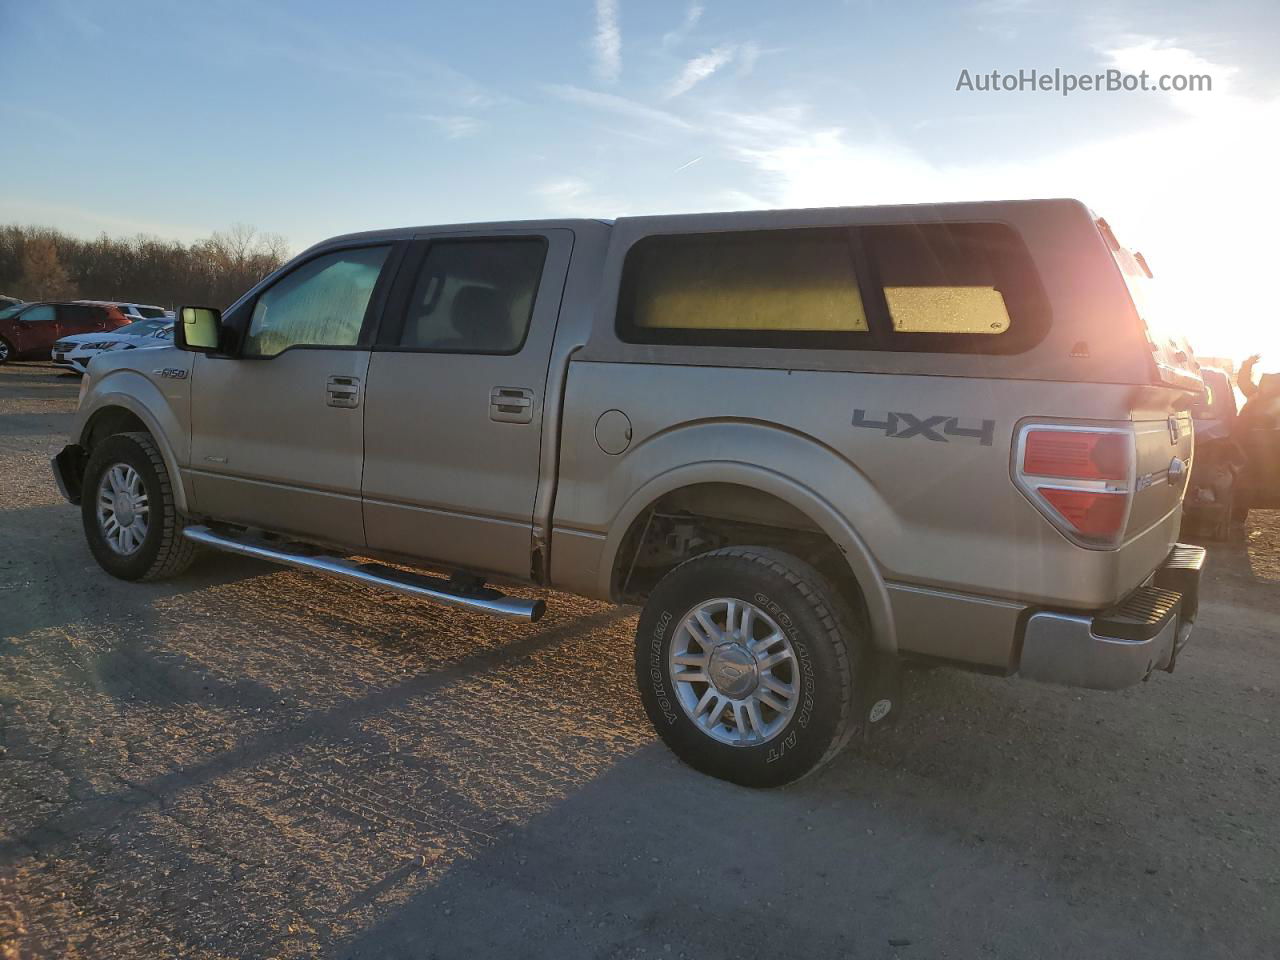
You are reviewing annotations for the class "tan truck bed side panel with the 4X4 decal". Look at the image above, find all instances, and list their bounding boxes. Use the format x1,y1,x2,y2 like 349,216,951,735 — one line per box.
553,362,1180,619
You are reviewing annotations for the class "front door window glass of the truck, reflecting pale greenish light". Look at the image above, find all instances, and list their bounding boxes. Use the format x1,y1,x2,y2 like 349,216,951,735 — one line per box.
242,246,390,357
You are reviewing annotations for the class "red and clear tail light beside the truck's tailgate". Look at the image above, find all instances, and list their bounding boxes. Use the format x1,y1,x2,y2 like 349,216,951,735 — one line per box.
1014,424,1137,549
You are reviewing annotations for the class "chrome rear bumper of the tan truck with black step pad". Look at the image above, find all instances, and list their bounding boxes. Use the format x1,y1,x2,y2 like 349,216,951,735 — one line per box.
1018,544,1204,690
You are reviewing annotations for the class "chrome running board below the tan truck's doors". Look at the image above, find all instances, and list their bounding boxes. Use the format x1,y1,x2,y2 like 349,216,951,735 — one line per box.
183,526,547,623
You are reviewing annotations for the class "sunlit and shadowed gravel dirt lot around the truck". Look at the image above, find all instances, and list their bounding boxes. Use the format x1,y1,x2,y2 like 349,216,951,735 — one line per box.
0,364,1280,960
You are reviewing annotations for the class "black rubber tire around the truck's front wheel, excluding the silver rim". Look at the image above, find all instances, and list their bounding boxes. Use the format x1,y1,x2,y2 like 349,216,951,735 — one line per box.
81,433,196,580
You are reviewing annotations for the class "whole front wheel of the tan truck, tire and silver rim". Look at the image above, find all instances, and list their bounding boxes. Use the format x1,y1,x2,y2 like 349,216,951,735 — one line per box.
81,433,196,580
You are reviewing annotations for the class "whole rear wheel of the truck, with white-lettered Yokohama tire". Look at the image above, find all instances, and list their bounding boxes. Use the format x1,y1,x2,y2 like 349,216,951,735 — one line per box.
636,547,861,787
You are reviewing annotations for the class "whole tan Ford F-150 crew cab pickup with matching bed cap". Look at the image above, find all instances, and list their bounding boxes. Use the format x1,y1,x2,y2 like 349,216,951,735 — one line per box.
54,200,1203,786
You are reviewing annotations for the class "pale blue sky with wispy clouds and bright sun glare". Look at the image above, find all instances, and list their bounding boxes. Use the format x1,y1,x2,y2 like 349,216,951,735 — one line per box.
0,0,1280,370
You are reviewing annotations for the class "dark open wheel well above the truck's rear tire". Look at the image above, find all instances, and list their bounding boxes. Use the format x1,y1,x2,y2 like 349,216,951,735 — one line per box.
612,484,865,609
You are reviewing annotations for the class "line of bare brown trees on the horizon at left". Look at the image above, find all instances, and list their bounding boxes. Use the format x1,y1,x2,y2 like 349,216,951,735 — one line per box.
0,224,289,308
